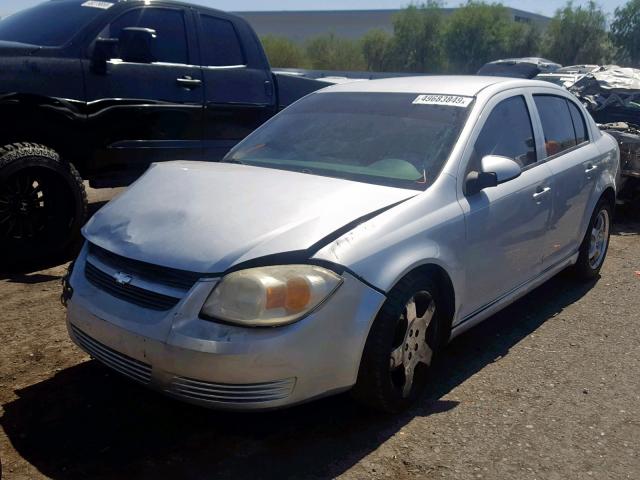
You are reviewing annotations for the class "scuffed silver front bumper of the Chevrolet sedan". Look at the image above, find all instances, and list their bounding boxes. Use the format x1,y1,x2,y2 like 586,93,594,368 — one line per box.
67,247,385,410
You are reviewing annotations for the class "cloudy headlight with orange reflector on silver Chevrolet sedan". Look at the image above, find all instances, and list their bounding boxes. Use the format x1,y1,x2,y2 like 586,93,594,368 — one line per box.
201,265,342,327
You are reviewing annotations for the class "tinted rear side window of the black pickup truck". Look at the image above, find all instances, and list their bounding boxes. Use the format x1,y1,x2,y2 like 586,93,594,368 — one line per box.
200,15,245,67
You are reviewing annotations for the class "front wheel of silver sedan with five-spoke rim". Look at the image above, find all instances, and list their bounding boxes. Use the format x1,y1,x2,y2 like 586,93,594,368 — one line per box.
352,274,444,413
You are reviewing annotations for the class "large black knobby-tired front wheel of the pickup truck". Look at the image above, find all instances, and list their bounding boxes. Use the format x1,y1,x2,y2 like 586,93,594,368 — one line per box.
0,143,87,266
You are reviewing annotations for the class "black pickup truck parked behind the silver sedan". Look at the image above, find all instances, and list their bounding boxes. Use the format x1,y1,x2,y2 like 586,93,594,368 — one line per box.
0,0,326,263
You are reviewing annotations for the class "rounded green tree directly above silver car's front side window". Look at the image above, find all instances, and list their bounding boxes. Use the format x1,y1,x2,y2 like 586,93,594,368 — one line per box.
444,0,532,73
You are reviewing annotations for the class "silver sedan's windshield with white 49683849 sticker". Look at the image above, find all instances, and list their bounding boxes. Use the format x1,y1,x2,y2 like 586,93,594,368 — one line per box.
224,93,472,190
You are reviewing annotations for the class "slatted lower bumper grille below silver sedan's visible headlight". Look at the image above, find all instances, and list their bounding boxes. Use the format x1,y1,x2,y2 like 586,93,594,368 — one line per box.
168,377,295,404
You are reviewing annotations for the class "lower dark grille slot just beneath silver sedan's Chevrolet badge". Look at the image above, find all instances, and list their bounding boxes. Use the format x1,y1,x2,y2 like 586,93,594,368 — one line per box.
84,261,180,311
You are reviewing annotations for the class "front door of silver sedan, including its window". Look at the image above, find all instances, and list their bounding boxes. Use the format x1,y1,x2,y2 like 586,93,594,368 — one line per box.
460,93,551,320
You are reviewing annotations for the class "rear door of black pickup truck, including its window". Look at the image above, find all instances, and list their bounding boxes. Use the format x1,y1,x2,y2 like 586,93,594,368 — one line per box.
197,13,276,161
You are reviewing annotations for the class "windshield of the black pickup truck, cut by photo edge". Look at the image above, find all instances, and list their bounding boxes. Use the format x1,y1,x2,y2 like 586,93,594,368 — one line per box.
0,0,113,47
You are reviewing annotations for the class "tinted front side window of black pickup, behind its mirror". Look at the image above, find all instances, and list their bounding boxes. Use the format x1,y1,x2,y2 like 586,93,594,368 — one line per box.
99,8,189,64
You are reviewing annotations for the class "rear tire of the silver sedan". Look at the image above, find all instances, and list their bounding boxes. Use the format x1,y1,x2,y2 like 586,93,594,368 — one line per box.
572,198,613,282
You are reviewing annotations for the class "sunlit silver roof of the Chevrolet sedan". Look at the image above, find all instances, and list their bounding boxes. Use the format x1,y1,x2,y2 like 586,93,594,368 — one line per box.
319,75,563,97
